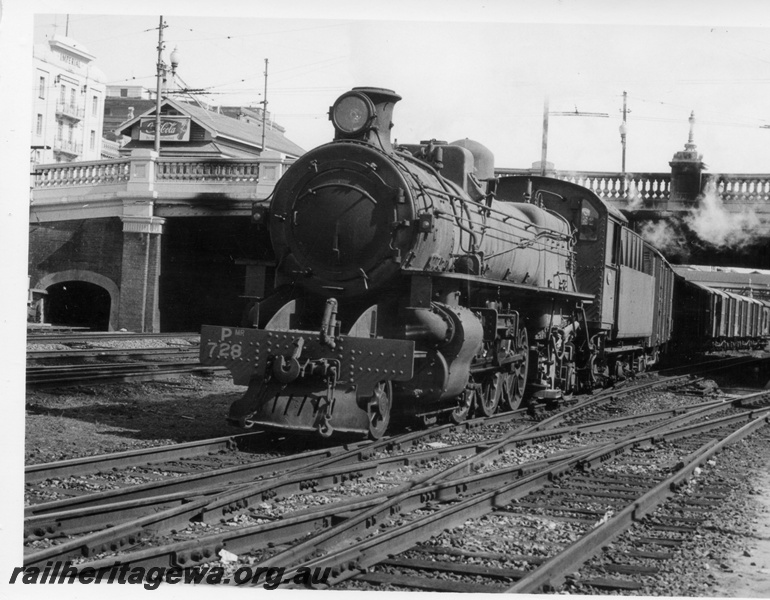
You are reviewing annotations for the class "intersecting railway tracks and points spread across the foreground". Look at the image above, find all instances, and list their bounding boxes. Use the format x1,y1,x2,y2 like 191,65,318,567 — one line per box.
16,360,766,592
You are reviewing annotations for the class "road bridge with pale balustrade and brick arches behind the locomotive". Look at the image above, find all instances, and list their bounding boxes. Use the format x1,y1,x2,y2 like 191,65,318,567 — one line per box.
29,149,770,331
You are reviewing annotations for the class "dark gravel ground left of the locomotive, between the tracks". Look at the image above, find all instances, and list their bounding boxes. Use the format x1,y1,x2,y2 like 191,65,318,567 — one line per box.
24,372,240,464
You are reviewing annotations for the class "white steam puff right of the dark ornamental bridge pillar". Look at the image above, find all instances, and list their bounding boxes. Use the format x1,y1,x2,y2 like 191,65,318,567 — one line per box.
684,180,770,249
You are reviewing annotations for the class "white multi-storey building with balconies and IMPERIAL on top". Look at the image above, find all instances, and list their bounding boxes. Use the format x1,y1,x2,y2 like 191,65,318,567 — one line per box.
30,35,106,164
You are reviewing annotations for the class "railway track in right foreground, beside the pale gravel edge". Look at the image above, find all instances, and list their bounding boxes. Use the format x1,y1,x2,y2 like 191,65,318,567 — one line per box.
274,394,770,593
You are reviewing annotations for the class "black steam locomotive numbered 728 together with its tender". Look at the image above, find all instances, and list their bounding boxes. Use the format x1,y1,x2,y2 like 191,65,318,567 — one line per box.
201,88,760,439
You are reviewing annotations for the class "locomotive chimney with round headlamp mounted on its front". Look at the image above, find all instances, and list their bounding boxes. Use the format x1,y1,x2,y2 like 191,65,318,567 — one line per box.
329,87,401,153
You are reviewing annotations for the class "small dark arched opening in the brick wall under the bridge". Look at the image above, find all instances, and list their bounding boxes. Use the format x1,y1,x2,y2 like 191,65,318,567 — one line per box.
45,281,111,331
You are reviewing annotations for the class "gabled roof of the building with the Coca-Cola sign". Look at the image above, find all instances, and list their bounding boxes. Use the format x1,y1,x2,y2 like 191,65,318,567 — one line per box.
118,98,305,157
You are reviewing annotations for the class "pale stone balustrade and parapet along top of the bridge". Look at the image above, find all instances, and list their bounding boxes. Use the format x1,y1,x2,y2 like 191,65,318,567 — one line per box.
30,150,770,222
